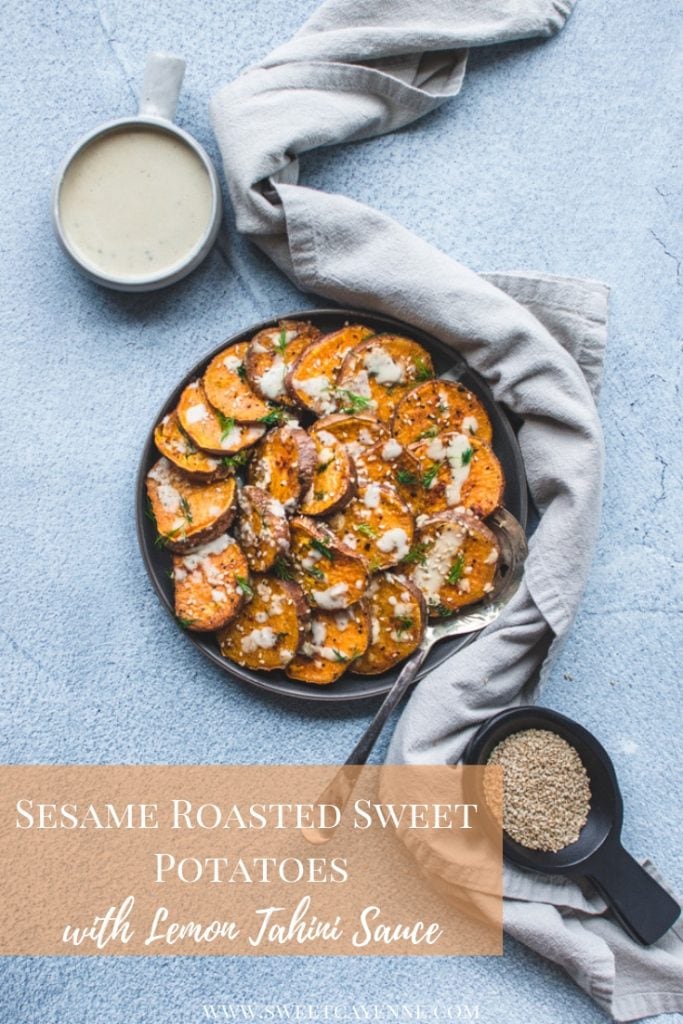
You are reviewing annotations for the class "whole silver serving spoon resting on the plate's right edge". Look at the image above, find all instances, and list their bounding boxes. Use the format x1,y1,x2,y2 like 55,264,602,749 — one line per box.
302,508,527,845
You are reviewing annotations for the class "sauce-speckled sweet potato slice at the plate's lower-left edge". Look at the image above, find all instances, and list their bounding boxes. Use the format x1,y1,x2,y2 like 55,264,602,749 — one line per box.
173,536,251,633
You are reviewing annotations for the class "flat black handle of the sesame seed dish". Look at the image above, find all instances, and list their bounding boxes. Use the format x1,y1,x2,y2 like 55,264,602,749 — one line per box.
586,842,681,946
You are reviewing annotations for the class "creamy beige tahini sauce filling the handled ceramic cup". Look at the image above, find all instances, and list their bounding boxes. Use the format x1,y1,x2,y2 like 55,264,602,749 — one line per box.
59,128,212,280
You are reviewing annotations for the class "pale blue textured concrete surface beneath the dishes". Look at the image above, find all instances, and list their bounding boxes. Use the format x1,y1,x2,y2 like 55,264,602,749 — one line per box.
0,0,683,1024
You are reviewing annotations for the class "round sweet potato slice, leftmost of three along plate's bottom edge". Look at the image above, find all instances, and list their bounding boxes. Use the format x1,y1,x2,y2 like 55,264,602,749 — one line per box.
217,575,310,672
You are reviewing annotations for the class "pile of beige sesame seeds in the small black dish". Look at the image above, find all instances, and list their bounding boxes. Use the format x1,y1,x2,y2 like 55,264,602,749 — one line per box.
487,729,591,853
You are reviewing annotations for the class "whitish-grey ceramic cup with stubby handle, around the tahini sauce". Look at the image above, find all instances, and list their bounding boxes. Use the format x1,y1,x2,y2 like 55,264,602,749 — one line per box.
52,53,222,292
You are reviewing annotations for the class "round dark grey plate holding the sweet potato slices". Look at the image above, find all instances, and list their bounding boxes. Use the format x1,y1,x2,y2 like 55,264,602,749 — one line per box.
135,309,527,700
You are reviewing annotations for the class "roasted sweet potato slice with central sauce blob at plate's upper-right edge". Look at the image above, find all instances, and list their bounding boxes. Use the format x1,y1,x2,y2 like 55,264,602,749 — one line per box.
337,334,434,423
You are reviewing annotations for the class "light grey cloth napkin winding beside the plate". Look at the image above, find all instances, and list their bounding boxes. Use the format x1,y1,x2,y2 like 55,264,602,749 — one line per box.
211,0,683,1021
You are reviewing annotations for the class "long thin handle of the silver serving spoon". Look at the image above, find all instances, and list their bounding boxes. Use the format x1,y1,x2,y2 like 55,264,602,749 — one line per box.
302,644,429,845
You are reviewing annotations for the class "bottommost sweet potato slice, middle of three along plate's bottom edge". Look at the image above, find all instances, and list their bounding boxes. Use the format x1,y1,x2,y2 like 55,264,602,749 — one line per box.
285,601,370,686
